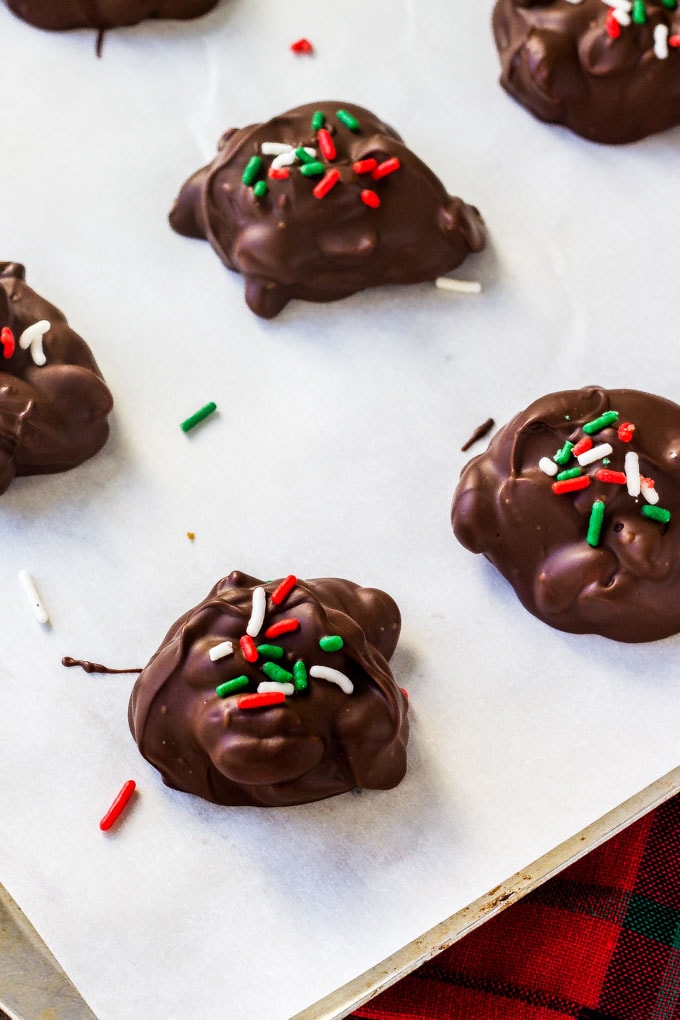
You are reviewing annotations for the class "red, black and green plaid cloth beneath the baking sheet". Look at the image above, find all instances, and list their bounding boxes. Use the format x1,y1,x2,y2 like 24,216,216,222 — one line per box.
353,795,680,1020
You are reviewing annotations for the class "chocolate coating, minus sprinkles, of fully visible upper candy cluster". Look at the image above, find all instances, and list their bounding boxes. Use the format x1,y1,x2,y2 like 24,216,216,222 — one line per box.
170,101,485,318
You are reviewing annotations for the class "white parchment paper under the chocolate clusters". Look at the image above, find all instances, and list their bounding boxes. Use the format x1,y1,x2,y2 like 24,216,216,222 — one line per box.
0,0,680,1020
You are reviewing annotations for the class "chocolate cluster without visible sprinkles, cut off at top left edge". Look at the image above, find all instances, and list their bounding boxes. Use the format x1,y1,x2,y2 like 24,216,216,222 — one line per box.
5,0,218,32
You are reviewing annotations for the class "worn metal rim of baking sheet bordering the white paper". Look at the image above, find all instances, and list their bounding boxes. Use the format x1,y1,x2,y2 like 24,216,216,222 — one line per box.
0,766,680,1020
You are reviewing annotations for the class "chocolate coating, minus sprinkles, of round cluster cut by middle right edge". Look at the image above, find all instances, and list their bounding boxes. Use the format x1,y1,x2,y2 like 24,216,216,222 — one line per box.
452,387,680,642
